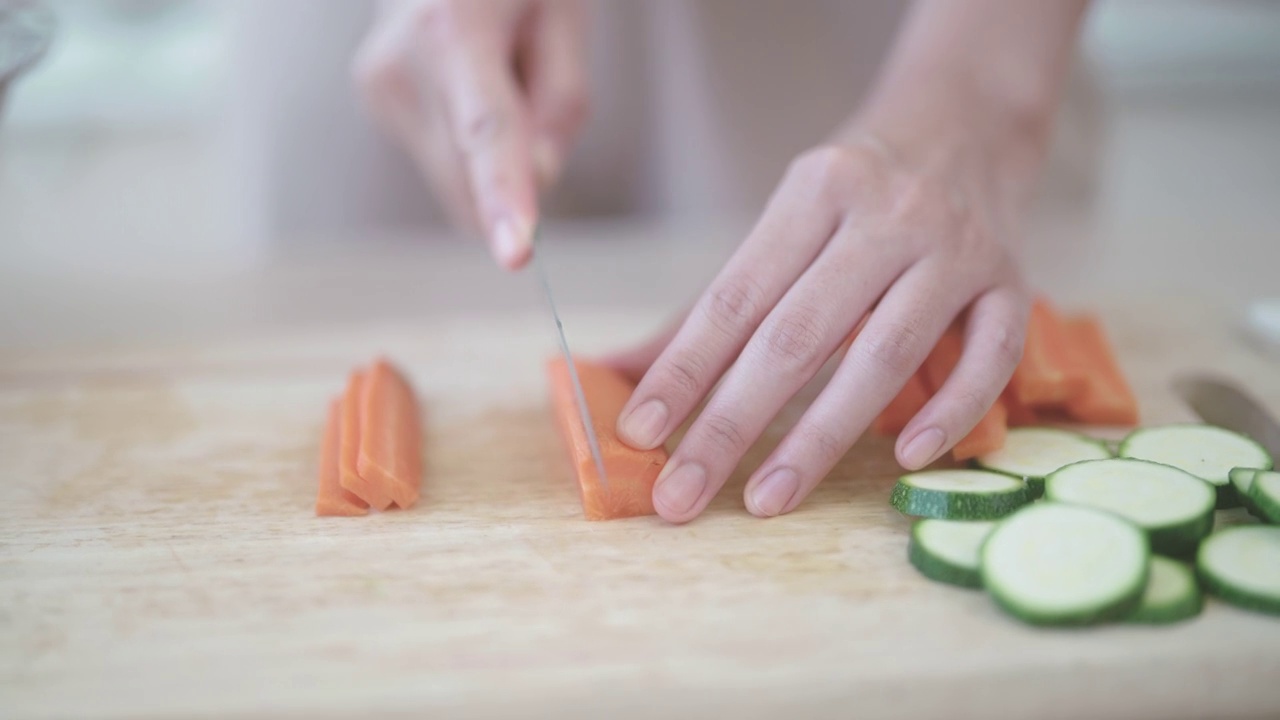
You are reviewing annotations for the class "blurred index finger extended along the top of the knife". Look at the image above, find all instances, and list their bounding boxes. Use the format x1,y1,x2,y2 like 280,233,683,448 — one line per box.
436,25,538,269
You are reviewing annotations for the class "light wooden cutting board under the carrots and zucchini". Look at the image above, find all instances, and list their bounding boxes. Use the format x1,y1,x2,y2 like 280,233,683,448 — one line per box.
0,298,1280,719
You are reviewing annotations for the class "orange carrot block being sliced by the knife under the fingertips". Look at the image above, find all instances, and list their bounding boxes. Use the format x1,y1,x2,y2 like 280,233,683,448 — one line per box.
547,357,667,520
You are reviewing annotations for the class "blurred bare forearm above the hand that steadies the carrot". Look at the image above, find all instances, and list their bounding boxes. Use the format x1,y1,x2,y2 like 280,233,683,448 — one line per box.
851,0,1088,198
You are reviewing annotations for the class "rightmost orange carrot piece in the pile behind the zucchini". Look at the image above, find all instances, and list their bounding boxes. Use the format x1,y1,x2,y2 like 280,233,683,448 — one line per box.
1064,315,1138,427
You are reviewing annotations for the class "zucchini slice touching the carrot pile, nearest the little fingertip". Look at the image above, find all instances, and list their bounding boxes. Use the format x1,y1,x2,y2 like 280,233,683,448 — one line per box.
978,428,1111,497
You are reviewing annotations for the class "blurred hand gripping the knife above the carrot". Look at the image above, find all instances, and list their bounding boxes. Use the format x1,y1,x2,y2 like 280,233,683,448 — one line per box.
353,0,588,269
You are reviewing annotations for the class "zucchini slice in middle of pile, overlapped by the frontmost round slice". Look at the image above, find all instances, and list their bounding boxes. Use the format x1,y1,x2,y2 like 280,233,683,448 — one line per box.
1044,459,1215,555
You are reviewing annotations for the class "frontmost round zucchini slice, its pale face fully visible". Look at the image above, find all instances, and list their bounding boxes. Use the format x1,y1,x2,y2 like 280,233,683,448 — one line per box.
982,502,1151,625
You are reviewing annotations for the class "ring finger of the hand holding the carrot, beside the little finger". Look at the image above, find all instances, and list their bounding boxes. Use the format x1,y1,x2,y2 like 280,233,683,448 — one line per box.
744,256,975,518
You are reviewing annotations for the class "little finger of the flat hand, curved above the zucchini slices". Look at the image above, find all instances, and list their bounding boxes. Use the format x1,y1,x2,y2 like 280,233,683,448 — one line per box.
896,286,1030,470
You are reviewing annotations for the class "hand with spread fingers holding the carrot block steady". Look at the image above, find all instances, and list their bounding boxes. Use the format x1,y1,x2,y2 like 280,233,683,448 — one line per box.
609,131,1030,521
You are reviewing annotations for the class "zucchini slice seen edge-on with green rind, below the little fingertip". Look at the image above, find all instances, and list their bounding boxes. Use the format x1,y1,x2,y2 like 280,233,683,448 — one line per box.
890,470,1030,520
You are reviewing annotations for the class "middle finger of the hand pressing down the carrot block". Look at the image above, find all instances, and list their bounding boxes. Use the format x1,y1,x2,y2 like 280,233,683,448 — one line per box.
654,225,911,521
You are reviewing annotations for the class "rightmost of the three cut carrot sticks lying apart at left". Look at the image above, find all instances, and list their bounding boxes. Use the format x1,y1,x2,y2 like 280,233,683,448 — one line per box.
356,357,422,509
